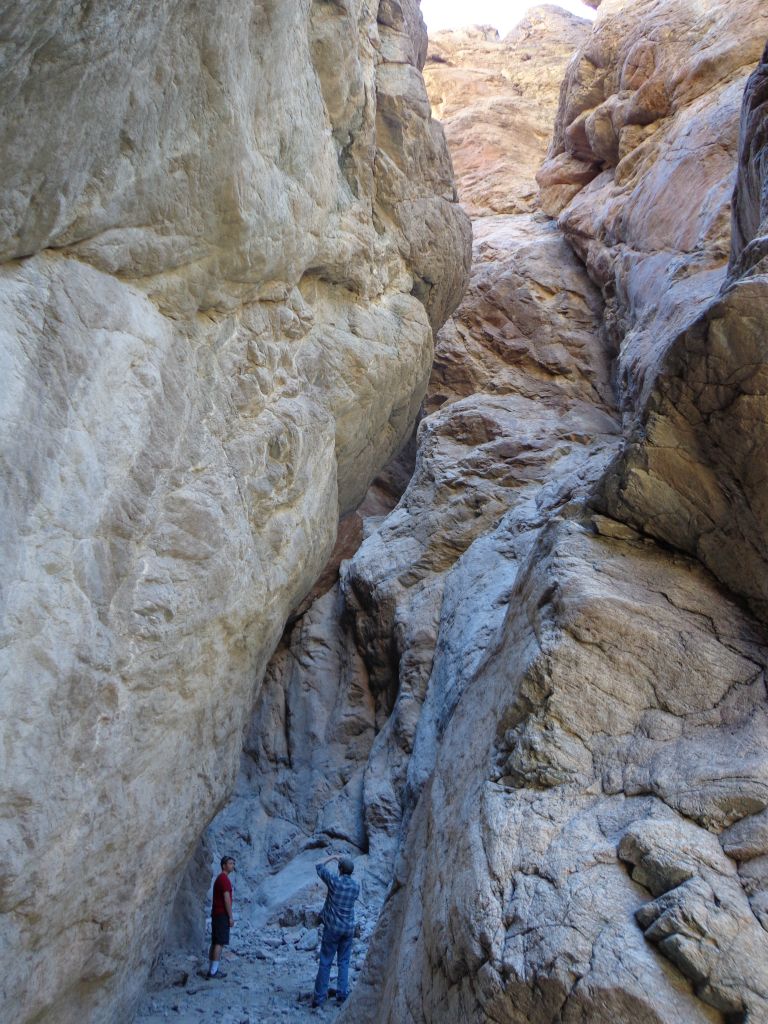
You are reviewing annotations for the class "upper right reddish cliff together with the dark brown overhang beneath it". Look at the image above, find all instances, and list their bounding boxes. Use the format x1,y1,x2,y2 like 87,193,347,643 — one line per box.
540,3,768,617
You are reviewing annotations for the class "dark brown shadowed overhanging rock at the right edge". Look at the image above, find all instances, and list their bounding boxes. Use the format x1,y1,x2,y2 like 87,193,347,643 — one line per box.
605,36,768,621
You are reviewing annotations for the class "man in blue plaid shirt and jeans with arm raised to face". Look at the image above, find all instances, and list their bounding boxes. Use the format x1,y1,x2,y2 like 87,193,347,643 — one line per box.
312,856,360,1008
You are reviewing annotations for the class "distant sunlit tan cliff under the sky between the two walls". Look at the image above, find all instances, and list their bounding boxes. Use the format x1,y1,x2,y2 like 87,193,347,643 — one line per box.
424,4,589,217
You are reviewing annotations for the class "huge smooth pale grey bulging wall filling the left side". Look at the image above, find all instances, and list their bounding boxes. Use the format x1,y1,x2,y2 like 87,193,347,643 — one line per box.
0,0,469,1024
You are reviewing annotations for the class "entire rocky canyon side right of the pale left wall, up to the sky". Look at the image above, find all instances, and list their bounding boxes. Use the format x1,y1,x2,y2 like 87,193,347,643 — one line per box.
201,0,768,1024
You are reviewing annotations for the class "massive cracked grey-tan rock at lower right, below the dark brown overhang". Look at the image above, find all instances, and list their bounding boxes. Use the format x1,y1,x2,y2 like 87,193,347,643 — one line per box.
348,514,768,1022
